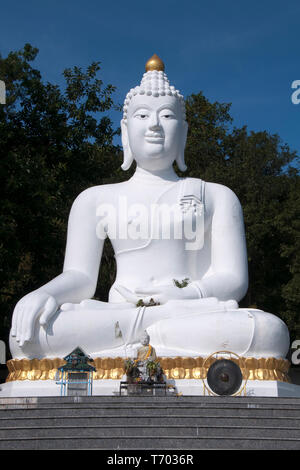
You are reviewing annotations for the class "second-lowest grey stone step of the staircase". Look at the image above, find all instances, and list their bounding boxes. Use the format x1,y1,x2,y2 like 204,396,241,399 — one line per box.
0,424,300,445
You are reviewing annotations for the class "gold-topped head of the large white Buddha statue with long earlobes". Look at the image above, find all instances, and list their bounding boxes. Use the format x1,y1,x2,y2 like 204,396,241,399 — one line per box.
121,55,187,171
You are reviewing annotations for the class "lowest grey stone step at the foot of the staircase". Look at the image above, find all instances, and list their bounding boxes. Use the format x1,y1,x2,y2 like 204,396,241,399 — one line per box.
0,433,300,451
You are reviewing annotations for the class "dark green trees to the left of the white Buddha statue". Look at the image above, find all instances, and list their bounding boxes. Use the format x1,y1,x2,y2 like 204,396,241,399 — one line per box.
0,44,120,346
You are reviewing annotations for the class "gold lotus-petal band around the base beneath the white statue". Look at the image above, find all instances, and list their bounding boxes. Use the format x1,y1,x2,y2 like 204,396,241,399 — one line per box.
6,357,291,382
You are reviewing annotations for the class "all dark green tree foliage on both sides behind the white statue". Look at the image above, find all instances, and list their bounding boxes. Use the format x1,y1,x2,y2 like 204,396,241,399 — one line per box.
0,44,300,352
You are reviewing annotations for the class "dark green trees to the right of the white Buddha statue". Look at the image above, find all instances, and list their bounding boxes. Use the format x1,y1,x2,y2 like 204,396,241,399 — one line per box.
186,93,300,338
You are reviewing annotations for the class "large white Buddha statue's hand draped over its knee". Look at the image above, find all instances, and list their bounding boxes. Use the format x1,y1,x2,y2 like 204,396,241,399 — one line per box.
11,290,58,347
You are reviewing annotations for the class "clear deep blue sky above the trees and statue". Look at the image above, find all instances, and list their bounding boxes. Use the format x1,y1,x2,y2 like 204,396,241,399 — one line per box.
0,0,300,160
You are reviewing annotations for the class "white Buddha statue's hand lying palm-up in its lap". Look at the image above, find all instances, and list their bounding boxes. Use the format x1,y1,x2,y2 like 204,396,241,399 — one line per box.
117,284,199,304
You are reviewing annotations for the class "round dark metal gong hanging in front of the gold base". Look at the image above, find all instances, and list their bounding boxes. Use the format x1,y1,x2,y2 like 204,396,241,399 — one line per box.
207,359,243,395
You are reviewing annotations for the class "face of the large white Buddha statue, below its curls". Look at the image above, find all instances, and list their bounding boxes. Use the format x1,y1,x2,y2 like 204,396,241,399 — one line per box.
122,94,187,171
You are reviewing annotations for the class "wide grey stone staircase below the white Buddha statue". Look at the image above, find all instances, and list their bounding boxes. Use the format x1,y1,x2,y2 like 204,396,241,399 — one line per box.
0,396,300,451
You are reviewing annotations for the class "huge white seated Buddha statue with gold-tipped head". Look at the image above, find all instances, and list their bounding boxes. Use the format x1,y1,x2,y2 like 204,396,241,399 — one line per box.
10,58,289,359
